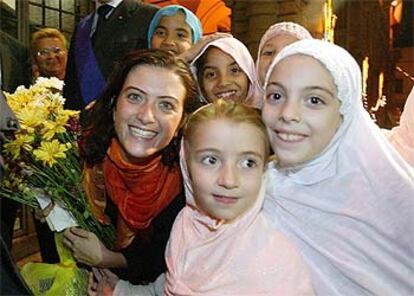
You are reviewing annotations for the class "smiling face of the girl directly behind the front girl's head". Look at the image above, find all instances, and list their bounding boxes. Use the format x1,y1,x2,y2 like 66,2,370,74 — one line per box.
201,47,249,102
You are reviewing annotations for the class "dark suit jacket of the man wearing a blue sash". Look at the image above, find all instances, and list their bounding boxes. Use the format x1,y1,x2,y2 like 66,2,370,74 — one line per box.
63,0,158,110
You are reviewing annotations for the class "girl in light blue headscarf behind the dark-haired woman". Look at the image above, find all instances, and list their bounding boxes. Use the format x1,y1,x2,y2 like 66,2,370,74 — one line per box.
147,5,203,55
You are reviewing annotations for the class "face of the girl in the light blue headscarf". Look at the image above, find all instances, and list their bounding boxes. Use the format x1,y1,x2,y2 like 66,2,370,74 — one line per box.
151,11,193,55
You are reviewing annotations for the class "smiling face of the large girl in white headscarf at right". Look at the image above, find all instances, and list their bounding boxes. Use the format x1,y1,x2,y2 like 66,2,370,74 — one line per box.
262,55,342,167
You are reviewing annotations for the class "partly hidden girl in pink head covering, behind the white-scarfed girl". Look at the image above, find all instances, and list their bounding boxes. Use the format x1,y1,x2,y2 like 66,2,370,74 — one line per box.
256,22,312,86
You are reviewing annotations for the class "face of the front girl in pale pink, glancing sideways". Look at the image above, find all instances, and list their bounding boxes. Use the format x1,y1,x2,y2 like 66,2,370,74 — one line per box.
187,119,266,221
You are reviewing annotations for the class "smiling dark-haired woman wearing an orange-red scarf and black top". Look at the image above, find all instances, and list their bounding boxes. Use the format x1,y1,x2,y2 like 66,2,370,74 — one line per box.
64,50,202,284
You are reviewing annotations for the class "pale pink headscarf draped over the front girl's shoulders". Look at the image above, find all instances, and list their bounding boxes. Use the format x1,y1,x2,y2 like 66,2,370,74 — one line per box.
165,139,313,296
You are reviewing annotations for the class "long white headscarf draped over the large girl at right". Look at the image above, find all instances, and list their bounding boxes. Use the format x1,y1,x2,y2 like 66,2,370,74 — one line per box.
264,40,414,295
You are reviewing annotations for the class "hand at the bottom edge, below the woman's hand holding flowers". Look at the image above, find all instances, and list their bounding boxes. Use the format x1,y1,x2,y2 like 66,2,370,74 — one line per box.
88,267,119,296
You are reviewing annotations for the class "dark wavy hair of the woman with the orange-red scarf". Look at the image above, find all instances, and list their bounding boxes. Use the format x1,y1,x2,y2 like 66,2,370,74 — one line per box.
80,49,199,165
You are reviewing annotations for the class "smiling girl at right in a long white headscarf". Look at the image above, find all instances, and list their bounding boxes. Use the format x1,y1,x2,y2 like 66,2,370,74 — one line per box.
262,39,414,295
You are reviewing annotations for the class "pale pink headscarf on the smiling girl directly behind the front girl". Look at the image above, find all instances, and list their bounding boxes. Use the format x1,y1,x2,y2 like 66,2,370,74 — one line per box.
190,37,262,108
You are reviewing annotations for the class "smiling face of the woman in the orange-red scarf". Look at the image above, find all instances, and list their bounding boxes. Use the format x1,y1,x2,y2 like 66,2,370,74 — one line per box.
113,65,186,162
